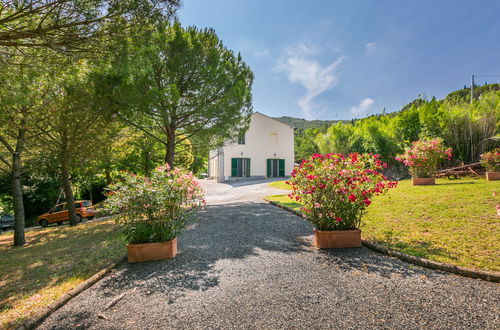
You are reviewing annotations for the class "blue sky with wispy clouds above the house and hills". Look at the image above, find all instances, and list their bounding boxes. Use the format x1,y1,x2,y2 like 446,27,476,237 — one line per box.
178,0,500,119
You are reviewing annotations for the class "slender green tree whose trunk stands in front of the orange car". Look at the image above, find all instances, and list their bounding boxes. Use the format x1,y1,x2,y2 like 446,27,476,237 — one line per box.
36,62,111,226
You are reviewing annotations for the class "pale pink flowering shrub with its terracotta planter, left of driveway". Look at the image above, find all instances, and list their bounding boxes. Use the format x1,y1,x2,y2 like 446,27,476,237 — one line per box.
105,165,205,262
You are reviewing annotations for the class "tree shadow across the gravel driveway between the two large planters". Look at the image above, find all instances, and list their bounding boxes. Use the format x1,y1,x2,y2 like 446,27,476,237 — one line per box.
95,203,440,303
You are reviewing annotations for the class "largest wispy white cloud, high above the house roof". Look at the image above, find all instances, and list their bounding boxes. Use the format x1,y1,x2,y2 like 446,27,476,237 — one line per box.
275,44,344,119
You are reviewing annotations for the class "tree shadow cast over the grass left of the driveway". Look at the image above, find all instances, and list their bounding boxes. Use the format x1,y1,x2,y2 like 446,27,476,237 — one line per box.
0,223,120,327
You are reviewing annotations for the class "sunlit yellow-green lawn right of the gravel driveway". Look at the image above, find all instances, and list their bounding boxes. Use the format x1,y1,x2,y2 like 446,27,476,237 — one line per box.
266,179,500,271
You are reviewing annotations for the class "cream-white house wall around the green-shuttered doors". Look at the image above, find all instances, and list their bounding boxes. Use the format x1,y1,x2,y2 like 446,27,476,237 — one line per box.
223,113,295,180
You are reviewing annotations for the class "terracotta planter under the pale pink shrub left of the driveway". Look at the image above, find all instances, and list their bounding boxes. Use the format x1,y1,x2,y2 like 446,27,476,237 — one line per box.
127,238,177,262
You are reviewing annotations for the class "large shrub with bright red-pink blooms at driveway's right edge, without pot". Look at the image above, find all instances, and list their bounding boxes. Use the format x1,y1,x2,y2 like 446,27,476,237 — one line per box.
287,153,397,230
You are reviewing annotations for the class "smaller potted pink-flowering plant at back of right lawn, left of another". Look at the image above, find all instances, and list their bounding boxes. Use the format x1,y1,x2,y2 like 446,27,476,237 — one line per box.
396,138,451,186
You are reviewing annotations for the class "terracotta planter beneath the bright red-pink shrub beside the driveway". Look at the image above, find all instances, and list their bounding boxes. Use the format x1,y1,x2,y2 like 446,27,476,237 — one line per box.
313,228,361,249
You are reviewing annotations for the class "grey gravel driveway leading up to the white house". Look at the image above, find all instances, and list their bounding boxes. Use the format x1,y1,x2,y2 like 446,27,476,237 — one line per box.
40,182,500,329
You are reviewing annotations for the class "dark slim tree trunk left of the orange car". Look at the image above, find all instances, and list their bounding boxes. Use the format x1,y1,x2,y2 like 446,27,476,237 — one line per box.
12,152,26,246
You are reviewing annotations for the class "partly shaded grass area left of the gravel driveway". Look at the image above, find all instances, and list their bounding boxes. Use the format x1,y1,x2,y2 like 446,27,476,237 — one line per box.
0,220,126,329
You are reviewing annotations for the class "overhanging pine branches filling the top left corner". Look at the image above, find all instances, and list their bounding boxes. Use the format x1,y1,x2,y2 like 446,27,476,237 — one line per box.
0,0,179,55
